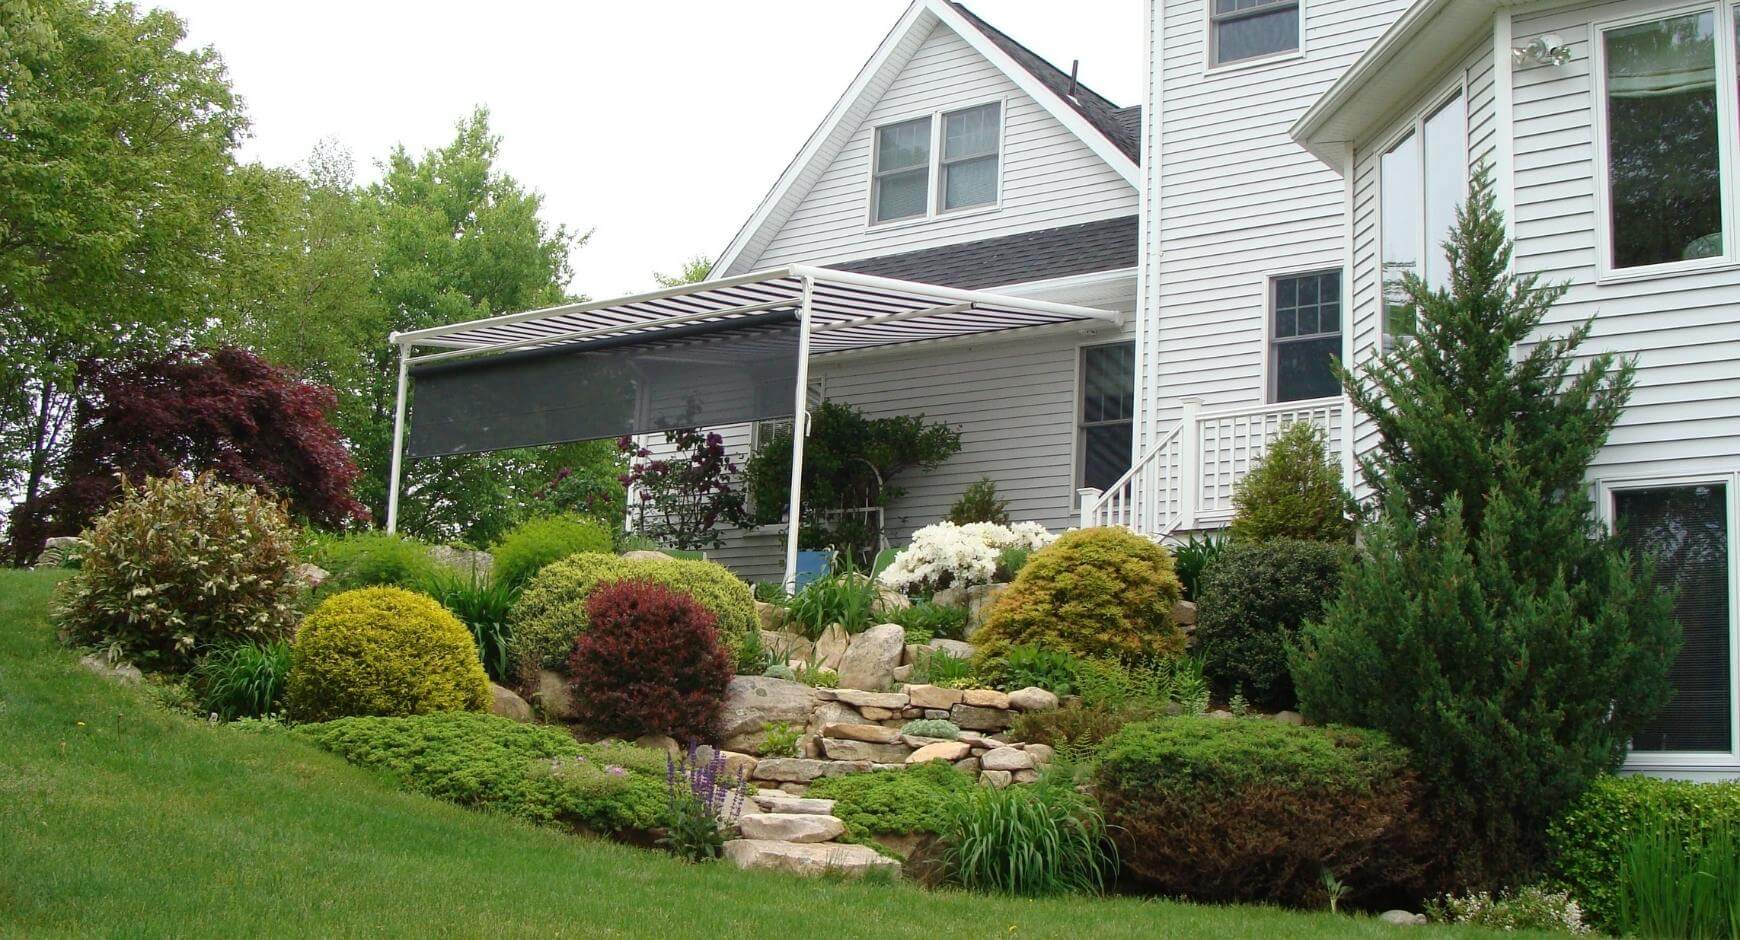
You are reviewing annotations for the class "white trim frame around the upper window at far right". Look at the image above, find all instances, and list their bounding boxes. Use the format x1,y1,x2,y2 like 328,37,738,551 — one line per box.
1589,0,1740,284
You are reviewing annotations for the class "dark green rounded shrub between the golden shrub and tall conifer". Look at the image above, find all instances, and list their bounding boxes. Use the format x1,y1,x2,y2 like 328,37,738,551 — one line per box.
1195,538,1349,708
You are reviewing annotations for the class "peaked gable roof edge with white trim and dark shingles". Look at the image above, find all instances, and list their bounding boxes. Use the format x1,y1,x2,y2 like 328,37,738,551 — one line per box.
713,0,1141,275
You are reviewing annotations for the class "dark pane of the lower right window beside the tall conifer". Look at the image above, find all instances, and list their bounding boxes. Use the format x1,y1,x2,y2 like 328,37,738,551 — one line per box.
1613,484,1733,752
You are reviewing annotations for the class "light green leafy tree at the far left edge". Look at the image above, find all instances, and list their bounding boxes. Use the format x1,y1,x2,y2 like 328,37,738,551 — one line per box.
0,0,245,498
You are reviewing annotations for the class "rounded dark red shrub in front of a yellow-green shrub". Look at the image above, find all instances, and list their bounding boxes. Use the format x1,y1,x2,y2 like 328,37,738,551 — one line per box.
569,581,731,742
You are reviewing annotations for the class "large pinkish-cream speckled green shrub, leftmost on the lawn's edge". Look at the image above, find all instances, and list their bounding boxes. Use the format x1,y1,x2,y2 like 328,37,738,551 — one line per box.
56,473,301,670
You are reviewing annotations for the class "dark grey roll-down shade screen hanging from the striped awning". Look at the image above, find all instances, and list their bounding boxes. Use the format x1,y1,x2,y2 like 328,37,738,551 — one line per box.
407,310,797,458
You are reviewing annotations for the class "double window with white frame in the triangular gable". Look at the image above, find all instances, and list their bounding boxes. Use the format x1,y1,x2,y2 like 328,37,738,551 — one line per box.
870,101,1002,223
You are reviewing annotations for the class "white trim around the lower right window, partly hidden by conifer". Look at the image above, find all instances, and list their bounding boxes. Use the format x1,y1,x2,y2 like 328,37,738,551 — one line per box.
1594,468,1740,775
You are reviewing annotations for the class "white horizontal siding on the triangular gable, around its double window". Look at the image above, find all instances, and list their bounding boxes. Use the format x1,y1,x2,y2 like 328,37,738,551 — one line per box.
751,24,1136,272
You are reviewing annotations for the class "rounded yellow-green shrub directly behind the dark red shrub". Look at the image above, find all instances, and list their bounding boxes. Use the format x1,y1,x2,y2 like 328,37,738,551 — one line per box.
508,552,759,682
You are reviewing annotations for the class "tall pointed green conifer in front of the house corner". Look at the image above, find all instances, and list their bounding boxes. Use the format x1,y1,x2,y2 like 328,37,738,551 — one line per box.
1289,171,1679,888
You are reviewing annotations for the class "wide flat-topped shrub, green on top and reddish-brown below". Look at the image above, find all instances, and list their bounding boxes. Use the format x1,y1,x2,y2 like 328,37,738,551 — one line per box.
1096,717,1422,905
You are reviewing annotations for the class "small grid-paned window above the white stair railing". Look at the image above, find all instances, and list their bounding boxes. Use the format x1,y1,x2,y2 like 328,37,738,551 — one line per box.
1268,268,1342,402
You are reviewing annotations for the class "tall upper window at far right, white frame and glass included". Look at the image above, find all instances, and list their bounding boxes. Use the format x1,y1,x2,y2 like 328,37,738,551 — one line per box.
1596,5,1740,272
